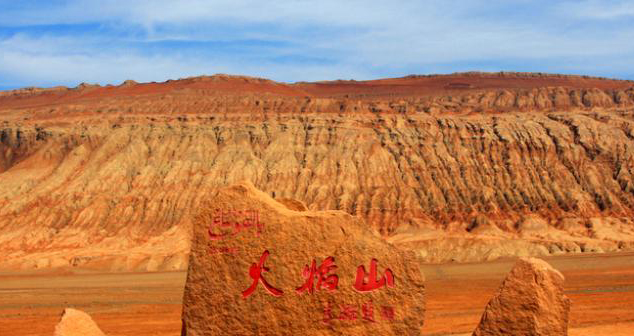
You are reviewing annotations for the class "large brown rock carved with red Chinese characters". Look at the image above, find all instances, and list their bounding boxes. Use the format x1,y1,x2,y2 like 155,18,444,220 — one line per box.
182,183,425,336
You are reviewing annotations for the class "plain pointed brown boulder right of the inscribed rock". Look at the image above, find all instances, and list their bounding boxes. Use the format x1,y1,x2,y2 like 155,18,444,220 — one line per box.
473,258,570,336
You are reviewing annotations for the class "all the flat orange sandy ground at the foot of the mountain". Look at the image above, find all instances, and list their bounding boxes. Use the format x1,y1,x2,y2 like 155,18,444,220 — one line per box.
0,253,634,336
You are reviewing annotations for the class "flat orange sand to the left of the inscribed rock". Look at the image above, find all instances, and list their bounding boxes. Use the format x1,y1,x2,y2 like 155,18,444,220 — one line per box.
0,272,186,336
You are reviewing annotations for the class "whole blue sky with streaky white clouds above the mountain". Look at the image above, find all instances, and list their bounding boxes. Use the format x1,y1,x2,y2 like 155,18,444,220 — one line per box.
0,0,634,90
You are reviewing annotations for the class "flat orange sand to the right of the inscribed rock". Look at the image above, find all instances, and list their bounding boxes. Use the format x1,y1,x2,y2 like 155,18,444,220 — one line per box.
424,253,634,336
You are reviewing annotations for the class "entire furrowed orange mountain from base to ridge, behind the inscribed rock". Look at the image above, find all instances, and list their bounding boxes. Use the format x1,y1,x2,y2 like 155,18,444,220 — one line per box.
0,74,634,270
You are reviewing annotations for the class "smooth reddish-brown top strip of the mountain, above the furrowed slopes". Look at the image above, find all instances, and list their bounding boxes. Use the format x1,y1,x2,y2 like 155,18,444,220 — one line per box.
0,72,634,110
